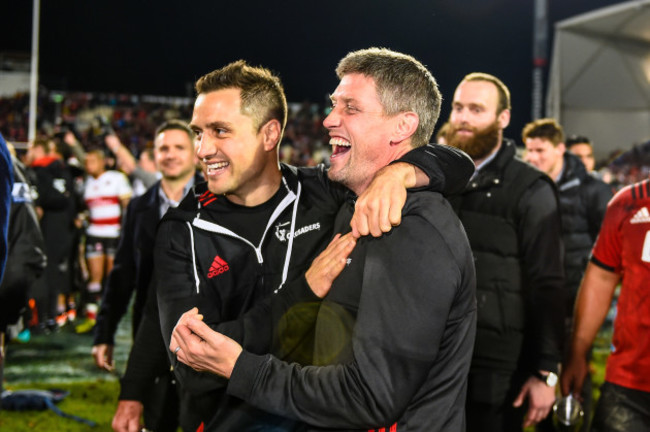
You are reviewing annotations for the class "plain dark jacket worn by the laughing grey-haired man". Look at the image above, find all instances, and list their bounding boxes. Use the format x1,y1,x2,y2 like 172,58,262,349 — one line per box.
228,187,476,432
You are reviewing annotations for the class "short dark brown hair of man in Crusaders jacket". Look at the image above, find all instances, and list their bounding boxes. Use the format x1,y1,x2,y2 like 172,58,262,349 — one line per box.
195,60,287,136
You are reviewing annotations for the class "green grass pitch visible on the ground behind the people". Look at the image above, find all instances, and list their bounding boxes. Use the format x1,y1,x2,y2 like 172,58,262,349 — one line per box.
0,312,611,432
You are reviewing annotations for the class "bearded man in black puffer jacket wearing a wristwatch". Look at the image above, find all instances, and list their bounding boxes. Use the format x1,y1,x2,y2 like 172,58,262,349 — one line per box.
447,73,565,432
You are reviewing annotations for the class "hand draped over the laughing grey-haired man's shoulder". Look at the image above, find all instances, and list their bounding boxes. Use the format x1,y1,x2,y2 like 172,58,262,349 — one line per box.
350,162,420,238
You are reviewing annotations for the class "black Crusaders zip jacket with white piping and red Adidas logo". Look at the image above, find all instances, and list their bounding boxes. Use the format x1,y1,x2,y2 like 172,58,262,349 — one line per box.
154,167,345,430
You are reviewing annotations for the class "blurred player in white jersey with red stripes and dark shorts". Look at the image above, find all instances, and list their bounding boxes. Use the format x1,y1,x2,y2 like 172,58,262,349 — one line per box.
76,150,133,333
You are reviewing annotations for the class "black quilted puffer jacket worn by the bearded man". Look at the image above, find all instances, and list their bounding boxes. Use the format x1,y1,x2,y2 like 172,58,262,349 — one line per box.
450,139,564,372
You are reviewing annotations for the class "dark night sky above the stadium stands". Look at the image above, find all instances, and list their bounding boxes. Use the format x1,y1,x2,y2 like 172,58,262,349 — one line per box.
0,0,621,138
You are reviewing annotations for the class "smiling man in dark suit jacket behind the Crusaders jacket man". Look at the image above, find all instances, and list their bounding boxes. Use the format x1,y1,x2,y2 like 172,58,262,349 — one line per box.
92,120,202,431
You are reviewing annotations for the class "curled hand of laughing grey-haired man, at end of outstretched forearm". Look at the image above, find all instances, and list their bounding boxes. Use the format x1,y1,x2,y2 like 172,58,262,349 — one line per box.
169,308,242,378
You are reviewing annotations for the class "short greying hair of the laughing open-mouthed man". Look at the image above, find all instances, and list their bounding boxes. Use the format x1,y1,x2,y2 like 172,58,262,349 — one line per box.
336,48,442,147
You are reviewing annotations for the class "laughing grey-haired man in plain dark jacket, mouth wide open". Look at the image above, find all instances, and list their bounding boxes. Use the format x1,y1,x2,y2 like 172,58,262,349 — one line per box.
170,48,476,431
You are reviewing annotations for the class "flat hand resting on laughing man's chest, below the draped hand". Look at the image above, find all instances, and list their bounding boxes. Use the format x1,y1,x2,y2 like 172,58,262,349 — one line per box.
305,233,357,298
